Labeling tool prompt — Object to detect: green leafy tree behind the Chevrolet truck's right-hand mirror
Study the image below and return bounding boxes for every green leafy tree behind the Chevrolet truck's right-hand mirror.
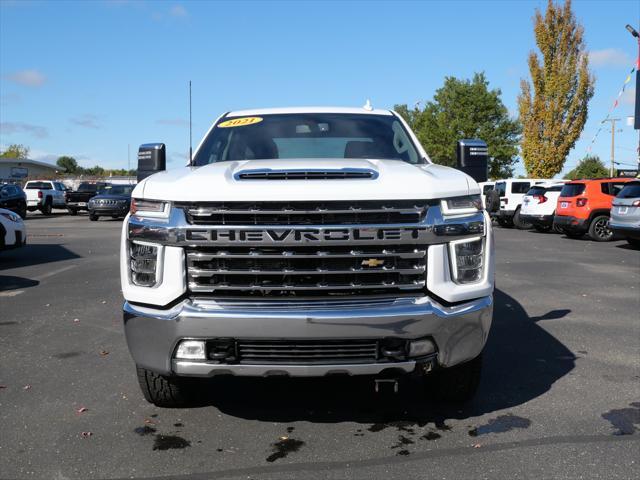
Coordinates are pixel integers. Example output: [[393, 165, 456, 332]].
[[395, 73, 521, 178]]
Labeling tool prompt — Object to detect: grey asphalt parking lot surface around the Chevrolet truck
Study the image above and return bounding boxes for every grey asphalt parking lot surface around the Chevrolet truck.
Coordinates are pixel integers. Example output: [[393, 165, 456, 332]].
[[0, 214, 640, 479]]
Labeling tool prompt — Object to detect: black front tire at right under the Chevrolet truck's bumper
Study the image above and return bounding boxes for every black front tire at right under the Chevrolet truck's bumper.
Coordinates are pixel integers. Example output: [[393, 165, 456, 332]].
[[425, 354, 482, 403]]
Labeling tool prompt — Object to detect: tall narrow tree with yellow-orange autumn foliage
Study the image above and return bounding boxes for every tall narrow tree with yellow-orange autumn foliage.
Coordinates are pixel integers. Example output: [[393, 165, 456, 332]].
[[518, 0, 595, 178]]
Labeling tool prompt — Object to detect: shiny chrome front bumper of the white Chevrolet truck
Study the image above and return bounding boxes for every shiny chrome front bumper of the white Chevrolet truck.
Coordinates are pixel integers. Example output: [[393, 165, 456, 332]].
[[124, 296, 493, 377]]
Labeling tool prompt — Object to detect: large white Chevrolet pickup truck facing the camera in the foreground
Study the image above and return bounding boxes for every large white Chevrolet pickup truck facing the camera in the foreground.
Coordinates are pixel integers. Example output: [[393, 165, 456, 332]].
[[121, 108, 494, 406]]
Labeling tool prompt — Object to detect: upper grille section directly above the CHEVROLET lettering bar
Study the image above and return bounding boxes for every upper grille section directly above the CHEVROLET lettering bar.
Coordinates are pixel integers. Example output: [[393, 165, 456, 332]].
[[177, 200, 429, 226]]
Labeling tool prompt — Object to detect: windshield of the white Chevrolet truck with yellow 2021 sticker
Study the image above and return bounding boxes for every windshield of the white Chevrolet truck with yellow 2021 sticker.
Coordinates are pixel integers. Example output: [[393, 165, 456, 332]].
[[194, 113, 422, 166]]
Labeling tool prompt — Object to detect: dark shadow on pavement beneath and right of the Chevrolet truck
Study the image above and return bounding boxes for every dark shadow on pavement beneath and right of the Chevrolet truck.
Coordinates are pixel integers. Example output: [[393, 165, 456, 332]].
[[199, 290, 576, 431]]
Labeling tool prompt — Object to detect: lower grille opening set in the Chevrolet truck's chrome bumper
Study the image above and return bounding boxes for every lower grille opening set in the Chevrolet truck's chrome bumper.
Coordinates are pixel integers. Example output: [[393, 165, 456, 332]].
[[236, 340, 378, 364]]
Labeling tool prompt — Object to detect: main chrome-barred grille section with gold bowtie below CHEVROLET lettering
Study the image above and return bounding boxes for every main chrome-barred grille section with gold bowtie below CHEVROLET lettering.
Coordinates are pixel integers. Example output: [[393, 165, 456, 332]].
[[187, 245, 427, 296]]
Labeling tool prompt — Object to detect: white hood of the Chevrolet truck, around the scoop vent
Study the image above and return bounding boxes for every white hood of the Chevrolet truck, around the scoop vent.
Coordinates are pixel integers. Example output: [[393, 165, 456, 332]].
[[133, 159, 478, 202]]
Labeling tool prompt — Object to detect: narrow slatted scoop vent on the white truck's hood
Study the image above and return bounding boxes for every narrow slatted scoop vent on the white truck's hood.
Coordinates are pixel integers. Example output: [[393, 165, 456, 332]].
[[233, 168, 378, 180]]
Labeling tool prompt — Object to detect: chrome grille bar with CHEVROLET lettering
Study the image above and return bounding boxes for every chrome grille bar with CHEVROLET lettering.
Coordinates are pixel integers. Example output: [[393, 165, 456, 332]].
[[186, 227, 427, 245]]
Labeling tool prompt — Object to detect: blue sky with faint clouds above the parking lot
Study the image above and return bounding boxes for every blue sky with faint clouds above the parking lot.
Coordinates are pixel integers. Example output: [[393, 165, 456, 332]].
[[0, 0, 640, 177]]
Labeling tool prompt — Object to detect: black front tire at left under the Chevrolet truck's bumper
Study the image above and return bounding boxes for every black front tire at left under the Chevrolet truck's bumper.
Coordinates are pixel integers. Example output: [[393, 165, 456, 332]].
[[136, 367, 194, 408]]
